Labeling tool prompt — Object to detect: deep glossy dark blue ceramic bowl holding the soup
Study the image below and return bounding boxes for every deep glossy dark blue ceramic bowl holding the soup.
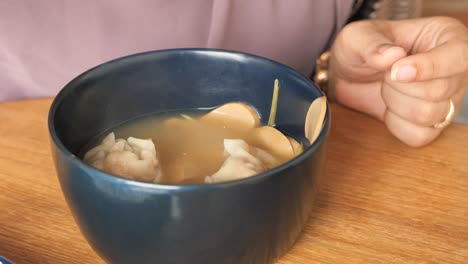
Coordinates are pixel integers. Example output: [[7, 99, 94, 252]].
[[49, 49, 330, 264]]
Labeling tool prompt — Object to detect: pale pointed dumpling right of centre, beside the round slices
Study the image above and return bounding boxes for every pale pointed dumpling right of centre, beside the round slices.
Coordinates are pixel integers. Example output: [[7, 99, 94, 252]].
[[205, 139, 277, 183]]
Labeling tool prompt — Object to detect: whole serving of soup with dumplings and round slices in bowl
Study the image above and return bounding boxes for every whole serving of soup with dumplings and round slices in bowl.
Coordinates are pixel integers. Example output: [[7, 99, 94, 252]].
[[83, 102, 302, 184]]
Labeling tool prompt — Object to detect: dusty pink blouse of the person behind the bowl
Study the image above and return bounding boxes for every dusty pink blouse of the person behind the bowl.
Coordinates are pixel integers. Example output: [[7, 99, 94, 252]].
[[0, 0, 353, 101]]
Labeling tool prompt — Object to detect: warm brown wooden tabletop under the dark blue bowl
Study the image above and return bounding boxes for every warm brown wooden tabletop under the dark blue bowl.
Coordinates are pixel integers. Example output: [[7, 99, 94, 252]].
[[0, 99, 468, 264]]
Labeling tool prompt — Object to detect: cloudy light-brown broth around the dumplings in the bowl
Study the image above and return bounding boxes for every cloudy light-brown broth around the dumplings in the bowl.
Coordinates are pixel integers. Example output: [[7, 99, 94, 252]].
[[82, 104, 302, 184]]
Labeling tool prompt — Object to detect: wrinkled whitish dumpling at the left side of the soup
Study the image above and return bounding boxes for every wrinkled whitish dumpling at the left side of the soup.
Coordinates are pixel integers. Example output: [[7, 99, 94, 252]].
[[83, 133, 161, 182]]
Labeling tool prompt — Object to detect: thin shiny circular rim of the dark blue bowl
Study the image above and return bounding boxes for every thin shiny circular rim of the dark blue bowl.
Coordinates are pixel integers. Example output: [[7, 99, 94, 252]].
[[47, 48, 331, 191]]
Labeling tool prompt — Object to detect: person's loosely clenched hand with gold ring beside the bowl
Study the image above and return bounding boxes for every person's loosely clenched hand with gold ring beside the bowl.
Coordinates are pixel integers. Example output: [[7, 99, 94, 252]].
[[329, 17, 468, 147]]
